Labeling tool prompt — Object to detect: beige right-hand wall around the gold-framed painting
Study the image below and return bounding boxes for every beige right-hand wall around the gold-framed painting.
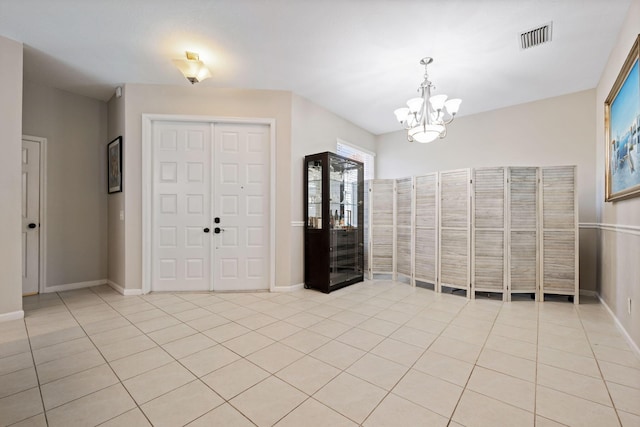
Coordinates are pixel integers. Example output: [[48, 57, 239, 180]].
[[595, 0, 640, 347]]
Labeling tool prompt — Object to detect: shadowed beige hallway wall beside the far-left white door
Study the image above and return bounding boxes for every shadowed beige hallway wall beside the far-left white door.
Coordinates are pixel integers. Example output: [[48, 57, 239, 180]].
[[22, 80, 107, 287]]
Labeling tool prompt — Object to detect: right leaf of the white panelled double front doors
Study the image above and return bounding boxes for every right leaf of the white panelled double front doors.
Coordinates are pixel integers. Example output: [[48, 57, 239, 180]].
[[213, 124, 270, 291]]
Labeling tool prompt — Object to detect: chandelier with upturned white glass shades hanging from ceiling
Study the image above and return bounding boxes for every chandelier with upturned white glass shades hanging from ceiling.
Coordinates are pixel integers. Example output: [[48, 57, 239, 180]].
[[394, 57, 462, 143]]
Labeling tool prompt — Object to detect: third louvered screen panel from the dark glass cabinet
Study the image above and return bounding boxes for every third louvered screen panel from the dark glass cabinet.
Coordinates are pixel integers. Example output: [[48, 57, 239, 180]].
[[414, 173, 438, 287]]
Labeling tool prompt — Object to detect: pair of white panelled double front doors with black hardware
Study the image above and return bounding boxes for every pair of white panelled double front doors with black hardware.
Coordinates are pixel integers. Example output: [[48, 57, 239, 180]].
[[151, 121, 271, 291]]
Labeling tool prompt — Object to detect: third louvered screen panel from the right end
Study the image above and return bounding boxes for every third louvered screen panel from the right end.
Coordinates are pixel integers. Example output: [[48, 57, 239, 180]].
[[471, 167, 507, 299]]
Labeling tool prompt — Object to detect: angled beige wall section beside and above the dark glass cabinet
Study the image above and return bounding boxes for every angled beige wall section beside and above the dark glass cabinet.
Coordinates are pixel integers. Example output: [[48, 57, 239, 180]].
[[290, 94, 376, 284]]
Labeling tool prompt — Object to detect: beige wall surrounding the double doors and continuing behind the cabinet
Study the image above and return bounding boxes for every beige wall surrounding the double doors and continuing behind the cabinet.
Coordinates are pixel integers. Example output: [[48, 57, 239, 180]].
[[109, 85, 375, 290]]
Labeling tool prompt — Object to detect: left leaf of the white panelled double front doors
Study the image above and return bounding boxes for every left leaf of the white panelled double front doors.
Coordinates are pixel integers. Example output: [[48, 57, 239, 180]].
[[151, 122, 212, 291]]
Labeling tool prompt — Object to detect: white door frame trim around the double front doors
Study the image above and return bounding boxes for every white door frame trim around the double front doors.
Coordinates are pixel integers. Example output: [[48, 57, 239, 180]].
[[141, 114, 276, 294]]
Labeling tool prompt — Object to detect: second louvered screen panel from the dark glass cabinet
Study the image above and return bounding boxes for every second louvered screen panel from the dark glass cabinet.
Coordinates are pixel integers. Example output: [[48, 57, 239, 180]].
[[395, 178, 413, 285]]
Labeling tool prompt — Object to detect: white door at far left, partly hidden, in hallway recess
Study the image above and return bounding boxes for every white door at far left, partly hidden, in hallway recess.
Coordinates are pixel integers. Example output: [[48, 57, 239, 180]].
[[22, 139, 40, 295]]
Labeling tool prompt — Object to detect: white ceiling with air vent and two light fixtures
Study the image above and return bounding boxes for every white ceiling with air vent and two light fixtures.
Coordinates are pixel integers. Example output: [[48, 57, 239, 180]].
[[0, 0, 630, 134]]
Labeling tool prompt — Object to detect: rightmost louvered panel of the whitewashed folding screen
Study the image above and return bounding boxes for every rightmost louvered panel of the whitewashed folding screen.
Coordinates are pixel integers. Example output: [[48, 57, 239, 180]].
[[540, 166, 579, 304]]
